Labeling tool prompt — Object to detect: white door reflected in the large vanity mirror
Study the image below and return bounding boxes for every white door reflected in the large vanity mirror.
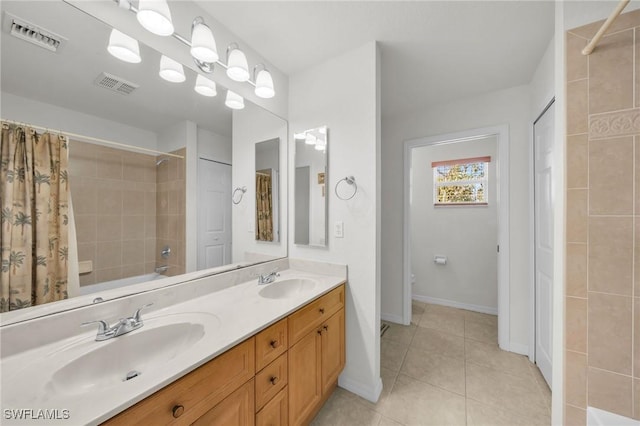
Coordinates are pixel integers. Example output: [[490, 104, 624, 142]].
[[198, 158, 231, 269]]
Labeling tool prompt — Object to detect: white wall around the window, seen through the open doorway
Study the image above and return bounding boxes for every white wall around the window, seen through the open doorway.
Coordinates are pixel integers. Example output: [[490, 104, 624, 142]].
[[410, 136, 498, 314]]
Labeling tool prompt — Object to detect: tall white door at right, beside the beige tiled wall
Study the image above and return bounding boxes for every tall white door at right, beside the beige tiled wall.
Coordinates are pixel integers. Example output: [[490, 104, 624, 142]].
[[533, 103, 555, 387]]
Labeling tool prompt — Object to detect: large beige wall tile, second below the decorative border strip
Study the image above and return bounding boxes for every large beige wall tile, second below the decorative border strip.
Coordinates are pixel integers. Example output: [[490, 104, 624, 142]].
[[589, 217, 633, 296]]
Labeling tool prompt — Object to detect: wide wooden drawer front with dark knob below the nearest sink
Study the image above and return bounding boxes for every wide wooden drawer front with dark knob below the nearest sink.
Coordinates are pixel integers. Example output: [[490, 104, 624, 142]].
[[104, 338, 255, 426]]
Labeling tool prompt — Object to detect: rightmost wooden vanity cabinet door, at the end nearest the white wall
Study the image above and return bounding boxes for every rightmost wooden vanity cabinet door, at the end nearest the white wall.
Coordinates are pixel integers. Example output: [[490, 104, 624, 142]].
[[321, 309, 345, 394]]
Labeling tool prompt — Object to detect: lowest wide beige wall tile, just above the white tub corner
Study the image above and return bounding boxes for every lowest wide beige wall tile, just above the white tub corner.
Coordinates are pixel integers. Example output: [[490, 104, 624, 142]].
[[588, 367, 633, 417]]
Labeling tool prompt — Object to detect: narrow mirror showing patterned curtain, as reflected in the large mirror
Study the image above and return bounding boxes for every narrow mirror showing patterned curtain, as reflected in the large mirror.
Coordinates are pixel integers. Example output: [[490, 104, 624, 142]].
[[256, 139, 280, 241]]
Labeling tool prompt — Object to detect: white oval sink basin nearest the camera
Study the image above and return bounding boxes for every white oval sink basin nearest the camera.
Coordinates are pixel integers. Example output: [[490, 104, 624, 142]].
[[46, 313, 220, 394]]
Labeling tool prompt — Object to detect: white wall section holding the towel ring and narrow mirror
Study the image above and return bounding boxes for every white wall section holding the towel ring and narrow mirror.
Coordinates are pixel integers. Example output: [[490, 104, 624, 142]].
[[289, 42, 382, 400]]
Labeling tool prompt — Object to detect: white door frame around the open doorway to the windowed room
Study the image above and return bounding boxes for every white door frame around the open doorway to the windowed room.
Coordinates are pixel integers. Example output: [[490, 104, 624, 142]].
[[402, 124, 511, 351]]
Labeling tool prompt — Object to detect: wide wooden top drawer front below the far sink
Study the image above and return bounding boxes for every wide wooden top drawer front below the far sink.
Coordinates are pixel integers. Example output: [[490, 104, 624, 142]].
[[289, 284, 344, 347]]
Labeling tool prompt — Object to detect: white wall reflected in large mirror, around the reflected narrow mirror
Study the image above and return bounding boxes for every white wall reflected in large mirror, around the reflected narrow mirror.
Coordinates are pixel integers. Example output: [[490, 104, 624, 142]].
[[231, 102, 289, 262]]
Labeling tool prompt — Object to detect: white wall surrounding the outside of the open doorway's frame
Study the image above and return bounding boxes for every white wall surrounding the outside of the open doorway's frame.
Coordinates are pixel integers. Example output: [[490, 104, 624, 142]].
[[382, 86, 531, 352]]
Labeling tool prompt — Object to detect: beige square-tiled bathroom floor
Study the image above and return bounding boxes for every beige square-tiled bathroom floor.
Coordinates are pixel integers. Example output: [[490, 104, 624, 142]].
[[312, 302, 551, 426]]
